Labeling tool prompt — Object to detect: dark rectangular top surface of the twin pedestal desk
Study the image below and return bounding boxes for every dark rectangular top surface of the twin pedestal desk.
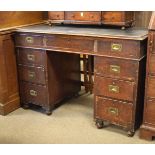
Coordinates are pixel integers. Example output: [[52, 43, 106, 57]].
[[15, 24, 148, 40]]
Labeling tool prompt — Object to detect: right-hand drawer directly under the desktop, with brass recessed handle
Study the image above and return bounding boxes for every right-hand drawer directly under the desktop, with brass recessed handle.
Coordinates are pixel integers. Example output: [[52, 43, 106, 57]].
[[97, 39, 141, 58]]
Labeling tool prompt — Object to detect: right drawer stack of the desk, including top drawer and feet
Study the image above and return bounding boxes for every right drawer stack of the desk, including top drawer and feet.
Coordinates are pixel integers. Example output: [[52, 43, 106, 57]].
[[94, 39, 147, 136]]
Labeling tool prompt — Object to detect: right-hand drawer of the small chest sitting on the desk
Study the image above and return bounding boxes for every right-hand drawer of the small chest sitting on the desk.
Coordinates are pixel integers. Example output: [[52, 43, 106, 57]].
[[102, 11, 124, 23]]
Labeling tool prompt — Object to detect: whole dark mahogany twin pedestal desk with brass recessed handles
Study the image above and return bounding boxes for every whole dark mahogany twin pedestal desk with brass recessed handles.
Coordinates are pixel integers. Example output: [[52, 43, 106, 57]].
[[15, 25, 148, 136]]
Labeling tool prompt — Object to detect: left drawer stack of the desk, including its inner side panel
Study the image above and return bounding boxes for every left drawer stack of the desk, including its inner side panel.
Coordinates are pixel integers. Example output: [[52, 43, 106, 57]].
[[15, 33, 80, 114]]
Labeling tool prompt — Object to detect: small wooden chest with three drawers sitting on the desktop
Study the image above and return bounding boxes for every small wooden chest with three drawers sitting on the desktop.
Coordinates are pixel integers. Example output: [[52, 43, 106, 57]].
[[48, 11, 134, 27]]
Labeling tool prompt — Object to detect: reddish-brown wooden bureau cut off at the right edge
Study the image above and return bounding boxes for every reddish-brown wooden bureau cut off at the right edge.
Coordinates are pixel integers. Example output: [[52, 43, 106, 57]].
[[140, 12, 155, 140]]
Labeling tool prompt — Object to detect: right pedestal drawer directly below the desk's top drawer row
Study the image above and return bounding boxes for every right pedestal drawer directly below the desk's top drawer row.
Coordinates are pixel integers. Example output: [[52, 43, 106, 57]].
[[95, 56, 139, 80]]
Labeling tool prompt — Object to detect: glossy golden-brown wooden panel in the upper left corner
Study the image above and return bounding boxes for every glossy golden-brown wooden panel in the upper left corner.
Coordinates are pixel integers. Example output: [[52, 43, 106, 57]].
[[0, 11, 46, 29]]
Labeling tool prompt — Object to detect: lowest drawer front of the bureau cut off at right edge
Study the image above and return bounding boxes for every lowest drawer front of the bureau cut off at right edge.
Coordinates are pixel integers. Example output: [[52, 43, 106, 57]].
[[144, 100, 155, 125]]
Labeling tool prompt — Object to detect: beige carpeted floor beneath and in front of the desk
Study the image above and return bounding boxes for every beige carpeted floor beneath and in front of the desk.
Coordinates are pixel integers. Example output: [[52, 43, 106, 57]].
[[0, 94, 155, 144]]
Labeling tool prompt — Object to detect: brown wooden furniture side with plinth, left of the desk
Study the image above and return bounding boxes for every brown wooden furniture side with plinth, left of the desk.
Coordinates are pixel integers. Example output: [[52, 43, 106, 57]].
[[0, 33, 20, 115]]
